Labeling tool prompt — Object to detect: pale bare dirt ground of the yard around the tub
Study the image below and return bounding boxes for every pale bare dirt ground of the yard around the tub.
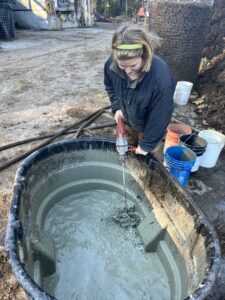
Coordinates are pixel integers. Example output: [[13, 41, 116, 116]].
[[0, 15, 225, 300]]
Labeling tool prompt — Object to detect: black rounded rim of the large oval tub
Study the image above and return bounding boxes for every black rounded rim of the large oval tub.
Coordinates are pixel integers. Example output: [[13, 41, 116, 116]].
[[5, 137, 221, 300]]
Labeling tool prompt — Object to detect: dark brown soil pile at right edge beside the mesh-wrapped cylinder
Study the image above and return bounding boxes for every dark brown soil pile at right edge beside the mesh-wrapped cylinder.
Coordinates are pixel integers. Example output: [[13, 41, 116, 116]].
[[196, 0, 225, 134]]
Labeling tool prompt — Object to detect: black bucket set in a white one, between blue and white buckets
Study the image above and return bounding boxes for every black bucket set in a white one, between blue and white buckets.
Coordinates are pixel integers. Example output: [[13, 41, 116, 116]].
[[179, 134, 207, 172]]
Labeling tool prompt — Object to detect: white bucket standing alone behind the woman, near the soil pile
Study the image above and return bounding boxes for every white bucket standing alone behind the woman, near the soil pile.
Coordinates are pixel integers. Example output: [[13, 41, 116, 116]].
[[173, 81, 193, 105]]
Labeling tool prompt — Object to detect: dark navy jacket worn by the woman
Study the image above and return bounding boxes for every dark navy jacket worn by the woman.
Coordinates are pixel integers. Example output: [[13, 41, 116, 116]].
[[104, 56, 176, 152]]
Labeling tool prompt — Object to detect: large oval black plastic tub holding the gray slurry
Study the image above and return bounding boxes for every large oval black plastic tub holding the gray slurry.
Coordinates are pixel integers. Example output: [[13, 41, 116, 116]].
[[6, 137, 220, 300]]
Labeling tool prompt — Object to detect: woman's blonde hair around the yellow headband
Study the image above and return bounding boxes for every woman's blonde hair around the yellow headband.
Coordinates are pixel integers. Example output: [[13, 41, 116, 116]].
[[112, 25, 161, 72]]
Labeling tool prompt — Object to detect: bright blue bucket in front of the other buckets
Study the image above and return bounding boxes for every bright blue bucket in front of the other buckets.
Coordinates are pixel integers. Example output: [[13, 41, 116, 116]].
[[165, 146, 196, 187]]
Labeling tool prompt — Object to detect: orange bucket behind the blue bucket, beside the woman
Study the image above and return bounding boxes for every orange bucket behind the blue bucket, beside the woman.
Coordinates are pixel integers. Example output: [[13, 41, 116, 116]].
[[164, 124, 192, 153]]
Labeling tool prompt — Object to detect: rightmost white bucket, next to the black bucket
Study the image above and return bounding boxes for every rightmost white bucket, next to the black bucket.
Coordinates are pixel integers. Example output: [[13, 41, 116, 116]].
[[199, 130, 225, 168]]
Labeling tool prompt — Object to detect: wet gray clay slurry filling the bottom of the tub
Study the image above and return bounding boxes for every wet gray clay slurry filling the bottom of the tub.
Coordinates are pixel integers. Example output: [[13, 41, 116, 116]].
[[44, 190, 170, 300]]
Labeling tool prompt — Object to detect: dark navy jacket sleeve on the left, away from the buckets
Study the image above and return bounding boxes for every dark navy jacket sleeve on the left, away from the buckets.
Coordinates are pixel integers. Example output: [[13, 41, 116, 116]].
[[104, 60, 120, 113]]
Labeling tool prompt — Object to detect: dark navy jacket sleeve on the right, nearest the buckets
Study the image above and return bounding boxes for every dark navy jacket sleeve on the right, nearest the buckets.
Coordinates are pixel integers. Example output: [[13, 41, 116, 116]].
[[139, 86, 175, 152]]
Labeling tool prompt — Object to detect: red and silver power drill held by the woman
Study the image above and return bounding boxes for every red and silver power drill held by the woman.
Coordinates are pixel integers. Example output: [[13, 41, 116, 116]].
[[116, 116, 137, 161]]
